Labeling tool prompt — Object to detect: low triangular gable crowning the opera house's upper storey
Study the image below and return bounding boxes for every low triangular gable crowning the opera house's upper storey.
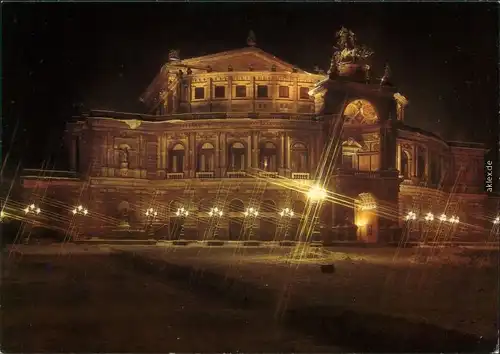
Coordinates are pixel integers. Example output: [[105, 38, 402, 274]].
[[170, 47, 304, 73]]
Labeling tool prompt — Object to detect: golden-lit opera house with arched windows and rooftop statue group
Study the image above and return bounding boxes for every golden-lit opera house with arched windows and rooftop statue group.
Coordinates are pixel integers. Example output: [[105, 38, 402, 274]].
[[22, 29, 494, 243]]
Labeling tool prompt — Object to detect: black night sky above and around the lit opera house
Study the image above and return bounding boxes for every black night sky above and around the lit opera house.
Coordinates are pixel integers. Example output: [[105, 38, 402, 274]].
[[2, 3, 499, 167]]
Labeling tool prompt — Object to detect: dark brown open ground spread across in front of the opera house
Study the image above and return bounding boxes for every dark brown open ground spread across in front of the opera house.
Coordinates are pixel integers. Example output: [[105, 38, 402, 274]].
[[1, 244, 498, 353]]
